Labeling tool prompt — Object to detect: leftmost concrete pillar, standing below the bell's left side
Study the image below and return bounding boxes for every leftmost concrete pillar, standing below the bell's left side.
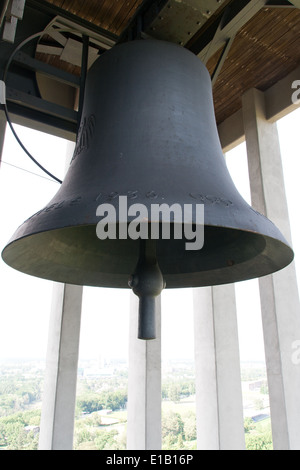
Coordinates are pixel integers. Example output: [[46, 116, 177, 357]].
[[39, 283, 82, 450]]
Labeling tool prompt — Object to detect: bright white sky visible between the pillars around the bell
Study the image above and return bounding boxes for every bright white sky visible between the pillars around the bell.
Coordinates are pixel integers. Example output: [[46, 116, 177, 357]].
[[0, 104, 300, 361]]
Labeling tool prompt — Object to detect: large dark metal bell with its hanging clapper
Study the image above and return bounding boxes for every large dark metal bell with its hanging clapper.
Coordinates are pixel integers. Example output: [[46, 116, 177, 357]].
[[2, 39, 293, 338]]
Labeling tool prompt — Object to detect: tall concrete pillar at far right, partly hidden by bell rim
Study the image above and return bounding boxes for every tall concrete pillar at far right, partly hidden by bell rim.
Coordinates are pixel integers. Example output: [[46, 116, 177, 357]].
[[243, 89, 300, 450]]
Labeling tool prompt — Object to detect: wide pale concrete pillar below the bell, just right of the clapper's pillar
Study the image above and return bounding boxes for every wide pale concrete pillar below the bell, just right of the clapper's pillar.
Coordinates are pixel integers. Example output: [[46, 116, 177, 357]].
[[194, 284, 245, 450]]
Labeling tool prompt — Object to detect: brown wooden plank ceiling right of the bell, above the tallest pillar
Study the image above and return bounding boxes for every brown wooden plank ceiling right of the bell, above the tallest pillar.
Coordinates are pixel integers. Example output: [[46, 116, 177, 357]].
[[207, 8, 300, 124]]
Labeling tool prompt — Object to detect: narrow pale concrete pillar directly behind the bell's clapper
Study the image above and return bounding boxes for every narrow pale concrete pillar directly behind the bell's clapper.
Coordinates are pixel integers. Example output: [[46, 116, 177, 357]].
[[127, 293, 161, 450]]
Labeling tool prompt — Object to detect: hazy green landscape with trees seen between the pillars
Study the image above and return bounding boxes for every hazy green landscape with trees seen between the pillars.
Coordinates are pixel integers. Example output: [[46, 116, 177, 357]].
[[0, 355, 272, 450]]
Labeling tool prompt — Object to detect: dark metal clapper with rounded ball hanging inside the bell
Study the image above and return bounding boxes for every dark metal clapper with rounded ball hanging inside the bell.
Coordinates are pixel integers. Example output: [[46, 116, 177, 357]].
[[128, 240, 165, 340]]
